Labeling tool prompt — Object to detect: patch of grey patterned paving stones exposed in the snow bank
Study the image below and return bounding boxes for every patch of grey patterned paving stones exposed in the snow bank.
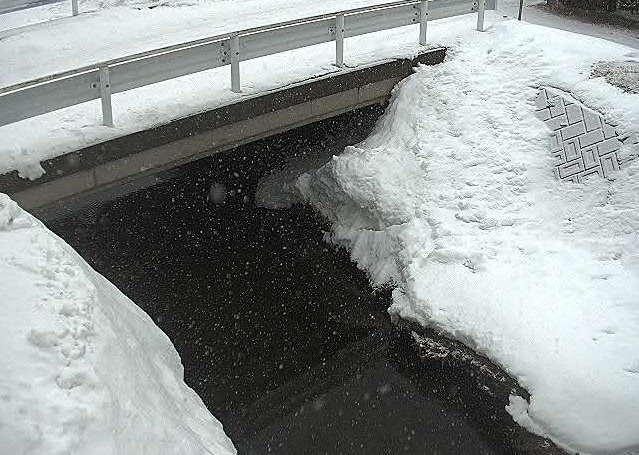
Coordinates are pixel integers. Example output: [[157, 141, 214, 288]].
[[535, 88, 634, 183]]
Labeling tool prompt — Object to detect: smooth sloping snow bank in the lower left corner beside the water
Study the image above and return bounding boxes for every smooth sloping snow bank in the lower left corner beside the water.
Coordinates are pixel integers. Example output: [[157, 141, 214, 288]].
[[0, 194, 236, 455]]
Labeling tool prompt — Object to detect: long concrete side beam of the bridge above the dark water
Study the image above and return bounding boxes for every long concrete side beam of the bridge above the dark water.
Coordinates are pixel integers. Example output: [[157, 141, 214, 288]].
[[0, 49, 445, 209]]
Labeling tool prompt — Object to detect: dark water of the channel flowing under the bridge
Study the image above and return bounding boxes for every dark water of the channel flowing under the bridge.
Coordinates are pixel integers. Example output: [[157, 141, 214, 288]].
[[45, 108, 504, 455]]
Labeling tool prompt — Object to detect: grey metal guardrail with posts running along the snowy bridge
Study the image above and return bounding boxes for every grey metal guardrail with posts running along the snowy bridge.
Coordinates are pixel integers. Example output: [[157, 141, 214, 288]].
[[0, 0, 494, 126]]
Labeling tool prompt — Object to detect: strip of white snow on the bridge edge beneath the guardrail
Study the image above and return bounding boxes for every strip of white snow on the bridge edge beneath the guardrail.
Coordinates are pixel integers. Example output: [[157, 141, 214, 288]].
[[0, 8, 470, 179]]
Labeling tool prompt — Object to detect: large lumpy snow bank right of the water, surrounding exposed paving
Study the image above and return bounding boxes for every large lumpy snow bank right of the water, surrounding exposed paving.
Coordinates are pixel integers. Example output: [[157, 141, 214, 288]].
[[296, 21, 639, 454]]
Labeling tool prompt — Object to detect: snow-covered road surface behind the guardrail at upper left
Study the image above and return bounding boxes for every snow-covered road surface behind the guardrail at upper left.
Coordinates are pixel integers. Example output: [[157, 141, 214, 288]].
[[0, 0, 388, 87]]
